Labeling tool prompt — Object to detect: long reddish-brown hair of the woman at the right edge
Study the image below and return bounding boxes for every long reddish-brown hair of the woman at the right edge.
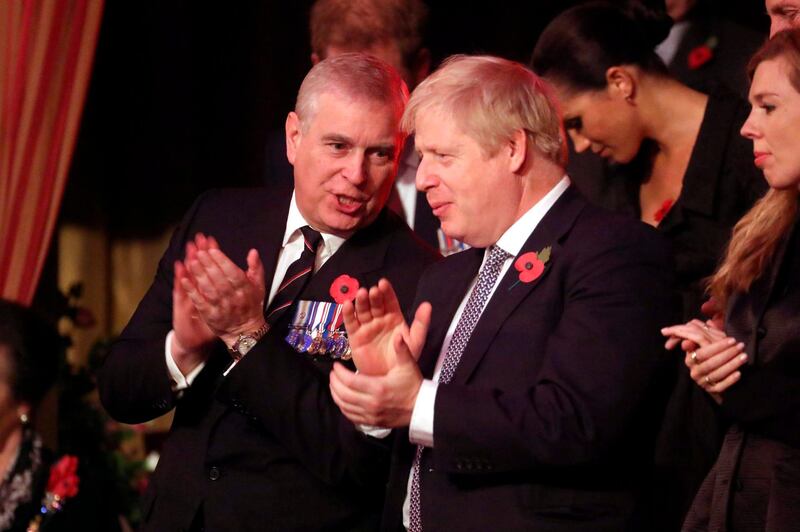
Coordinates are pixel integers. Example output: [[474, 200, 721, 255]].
[[708, 29, 800, 308]]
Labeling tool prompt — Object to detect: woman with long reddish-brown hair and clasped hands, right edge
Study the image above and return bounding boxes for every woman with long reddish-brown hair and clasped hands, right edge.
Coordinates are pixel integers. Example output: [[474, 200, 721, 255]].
[[663, 29, 800, 531]]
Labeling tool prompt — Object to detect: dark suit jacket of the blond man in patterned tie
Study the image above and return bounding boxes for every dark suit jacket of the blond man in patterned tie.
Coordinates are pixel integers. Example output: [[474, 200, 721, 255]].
[[383, 187, 677, 531]]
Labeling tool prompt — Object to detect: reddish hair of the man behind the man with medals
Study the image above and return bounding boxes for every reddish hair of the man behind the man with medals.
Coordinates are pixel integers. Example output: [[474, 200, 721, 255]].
[[310, 0, 428, 68]]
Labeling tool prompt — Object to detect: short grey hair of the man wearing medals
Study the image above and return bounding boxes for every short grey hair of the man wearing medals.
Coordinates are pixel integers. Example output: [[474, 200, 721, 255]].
[[295, 53, 408, 130]]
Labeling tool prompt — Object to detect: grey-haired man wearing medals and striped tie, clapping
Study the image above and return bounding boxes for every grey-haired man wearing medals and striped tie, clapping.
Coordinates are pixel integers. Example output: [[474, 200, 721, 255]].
[[99, 54, 435, 531]]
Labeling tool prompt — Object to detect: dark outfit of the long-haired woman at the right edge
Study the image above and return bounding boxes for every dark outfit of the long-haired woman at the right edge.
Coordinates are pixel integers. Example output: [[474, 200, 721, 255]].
[[684, 203, 800, 532]]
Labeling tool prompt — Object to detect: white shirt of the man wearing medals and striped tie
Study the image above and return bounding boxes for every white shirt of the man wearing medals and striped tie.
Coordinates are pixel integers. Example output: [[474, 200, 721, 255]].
[[164, 192, 346, 391]]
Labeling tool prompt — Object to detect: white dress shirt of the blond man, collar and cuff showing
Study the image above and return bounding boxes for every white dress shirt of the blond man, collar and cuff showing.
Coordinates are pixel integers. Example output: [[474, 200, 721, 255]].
[[403, 175, 570, 528]]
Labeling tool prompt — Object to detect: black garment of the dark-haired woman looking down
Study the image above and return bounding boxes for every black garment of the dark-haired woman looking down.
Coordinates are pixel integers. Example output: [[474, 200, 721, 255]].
[[580, 88, 767, 531]]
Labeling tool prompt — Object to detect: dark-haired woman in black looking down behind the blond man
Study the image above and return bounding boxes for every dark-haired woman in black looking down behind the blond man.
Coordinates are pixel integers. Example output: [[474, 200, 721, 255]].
[[532, 2, 766, 530]]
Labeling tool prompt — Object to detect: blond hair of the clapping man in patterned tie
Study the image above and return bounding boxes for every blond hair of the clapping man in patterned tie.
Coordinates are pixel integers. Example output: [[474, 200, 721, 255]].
[[400, 55, 566, 166]]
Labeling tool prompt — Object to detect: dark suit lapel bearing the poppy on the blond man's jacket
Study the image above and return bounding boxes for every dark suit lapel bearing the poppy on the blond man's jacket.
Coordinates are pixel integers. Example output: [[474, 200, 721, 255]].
[[451, 187, 586, 384]]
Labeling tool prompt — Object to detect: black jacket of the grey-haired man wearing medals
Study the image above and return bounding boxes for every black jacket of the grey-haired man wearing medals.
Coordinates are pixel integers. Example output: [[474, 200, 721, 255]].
[[99, 181, 435, 532]]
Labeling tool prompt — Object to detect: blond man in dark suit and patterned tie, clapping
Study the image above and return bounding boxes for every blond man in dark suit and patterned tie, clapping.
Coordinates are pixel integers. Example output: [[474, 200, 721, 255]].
[[331, 56, 677, 532]]
